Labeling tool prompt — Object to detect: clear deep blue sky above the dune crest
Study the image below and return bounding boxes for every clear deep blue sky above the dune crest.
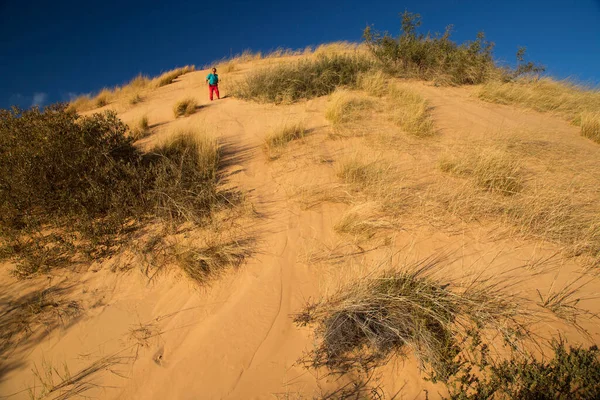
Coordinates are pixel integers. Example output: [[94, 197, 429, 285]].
[[0, 0, 600, 108]]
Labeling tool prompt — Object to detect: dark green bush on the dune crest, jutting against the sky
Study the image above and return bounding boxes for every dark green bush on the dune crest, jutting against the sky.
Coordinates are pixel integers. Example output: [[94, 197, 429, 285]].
[[363, 11, 500, 85]]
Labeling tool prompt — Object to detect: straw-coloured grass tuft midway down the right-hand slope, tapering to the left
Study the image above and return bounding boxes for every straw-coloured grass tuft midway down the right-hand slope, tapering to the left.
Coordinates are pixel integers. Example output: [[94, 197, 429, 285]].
[[439, 149, 523, 195]]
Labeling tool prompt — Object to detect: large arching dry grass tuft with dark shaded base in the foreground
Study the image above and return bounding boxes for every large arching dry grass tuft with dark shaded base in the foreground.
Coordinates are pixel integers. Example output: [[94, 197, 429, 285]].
[[295, 258, 538, 377]]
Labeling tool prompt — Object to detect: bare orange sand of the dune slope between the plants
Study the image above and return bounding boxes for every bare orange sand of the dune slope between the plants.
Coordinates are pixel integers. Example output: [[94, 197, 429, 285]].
[[0, 57, 600, 399]]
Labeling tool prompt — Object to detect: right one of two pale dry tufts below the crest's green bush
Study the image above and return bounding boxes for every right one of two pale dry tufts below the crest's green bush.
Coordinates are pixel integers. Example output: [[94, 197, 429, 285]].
[[388, 85, 435, 137]]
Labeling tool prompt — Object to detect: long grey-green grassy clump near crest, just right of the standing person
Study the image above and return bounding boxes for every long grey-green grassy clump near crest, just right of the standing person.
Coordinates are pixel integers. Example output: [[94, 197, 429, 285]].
[[234, 54, 372, 103]]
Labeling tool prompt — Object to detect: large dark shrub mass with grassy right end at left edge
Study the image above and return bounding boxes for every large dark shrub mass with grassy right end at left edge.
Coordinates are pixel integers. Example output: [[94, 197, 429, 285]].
[[0, 105, 225, 276]]
